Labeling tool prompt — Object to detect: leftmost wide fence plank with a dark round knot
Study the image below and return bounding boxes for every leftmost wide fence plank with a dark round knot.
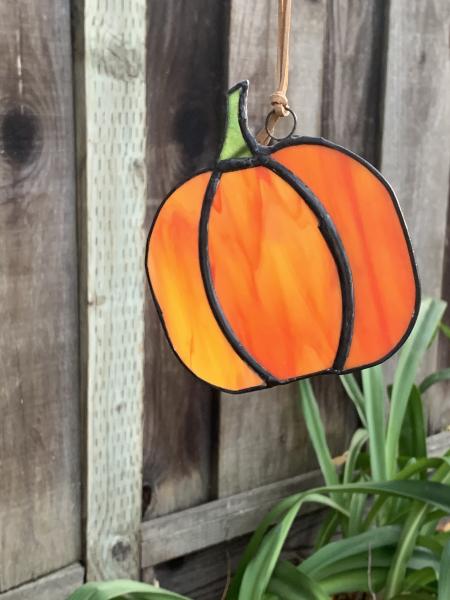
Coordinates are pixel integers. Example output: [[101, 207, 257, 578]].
[[0, 0, 81, 591]]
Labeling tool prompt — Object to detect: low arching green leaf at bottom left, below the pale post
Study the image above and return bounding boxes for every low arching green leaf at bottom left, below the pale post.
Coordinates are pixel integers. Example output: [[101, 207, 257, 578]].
[[67, 579, 189, 600]]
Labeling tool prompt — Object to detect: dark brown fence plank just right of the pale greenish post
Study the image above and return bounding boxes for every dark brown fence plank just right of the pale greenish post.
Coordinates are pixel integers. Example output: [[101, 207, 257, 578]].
[[144, 0, 228, 519]]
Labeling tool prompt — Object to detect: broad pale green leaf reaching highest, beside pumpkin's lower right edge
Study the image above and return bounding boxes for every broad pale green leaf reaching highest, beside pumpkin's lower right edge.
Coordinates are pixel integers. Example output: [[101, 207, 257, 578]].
[[386, 298, 446, 478]]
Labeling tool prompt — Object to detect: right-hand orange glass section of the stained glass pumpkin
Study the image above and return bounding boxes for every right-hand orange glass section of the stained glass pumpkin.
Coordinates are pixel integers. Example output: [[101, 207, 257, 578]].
[[272, 144, 416, 369]]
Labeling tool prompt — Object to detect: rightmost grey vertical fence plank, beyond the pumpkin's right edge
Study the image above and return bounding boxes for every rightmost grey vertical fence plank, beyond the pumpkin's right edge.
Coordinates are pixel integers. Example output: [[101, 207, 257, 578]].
[[382, 0, 450, 431]]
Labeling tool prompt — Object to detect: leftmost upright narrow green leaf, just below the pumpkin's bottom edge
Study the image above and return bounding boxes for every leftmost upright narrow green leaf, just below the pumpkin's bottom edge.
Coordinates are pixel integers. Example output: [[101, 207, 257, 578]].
[[299, 379, 339, 485]]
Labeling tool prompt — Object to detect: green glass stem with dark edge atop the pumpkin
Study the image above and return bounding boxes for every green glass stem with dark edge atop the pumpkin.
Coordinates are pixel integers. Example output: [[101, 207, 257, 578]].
[[219, 81, 252, 161]]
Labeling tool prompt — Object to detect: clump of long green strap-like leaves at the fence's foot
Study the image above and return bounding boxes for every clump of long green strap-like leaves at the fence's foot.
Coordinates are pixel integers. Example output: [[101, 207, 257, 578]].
[[69, 299, 450, 600]]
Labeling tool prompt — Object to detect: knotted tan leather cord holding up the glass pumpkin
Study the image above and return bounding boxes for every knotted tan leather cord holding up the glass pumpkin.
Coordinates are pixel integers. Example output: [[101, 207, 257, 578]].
[[256, 0, 292, 145]]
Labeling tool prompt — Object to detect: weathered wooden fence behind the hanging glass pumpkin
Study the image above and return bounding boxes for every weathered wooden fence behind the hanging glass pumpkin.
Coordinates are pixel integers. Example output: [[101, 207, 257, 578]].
[[0, 0, 450, 600]]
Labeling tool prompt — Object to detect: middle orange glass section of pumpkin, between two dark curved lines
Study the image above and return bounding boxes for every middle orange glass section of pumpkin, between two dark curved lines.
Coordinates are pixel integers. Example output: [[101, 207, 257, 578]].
[[208, 167, 342, 380]]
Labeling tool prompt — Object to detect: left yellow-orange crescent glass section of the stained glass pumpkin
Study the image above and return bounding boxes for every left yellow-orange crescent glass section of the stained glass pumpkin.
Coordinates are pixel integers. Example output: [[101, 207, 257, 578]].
[[147, 173, 264, 391]]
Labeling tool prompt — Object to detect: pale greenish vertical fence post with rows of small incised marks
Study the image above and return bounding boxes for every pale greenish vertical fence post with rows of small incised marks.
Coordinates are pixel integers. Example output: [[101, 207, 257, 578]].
[[75, 0, 146, 580]]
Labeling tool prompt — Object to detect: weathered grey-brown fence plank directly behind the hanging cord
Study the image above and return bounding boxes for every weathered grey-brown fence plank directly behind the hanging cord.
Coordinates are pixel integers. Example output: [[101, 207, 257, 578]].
[[218, 0, 384, 496]]
